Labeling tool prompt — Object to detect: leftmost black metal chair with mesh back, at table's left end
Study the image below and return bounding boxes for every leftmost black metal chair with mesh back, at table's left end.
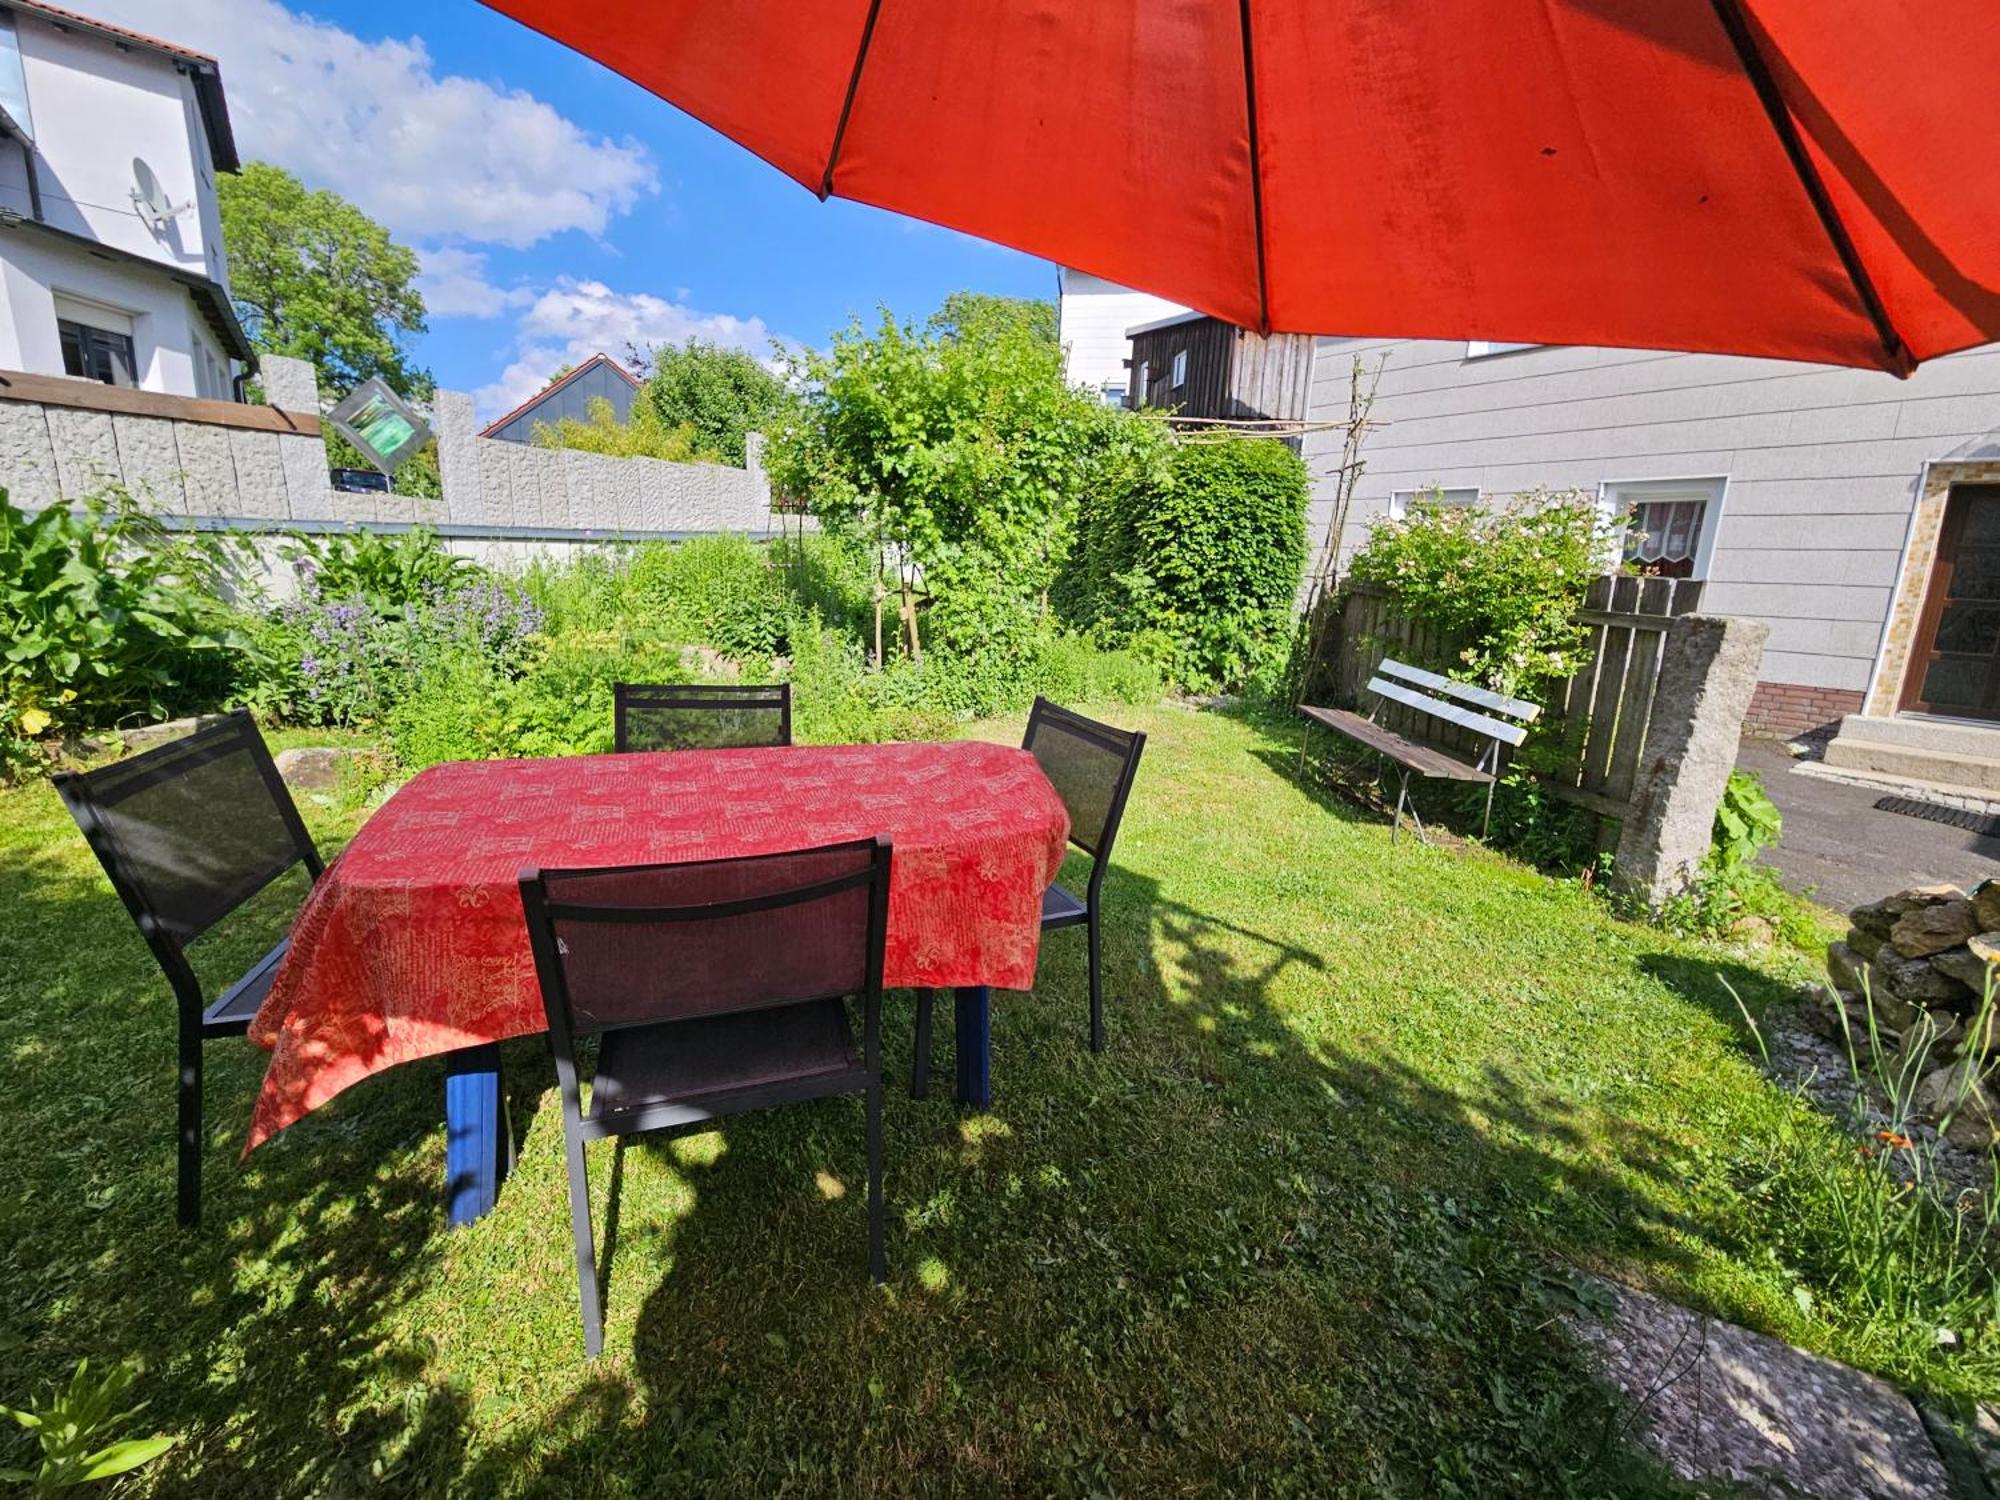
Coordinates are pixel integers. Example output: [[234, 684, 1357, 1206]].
[[54, 710, 324, 1224]]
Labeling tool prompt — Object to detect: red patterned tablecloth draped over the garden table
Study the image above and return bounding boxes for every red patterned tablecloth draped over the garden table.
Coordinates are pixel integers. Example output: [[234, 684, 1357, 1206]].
[[250, 740, 1070, 1146]]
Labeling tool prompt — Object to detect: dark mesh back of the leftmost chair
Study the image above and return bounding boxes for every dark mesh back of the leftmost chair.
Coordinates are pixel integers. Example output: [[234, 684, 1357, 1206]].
[[54, 712, 320, 944]]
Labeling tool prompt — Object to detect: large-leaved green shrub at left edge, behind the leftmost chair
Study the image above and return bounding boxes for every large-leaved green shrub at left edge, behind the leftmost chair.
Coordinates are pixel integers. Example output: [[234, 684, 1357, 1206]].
[[0, 488, 244, 768]]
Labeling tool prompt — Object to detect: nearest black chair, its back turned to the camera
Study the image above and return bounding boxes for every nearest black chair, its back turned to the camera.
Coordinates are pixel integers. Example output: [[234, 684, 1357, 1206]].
[[520, 836, 890, 1358]]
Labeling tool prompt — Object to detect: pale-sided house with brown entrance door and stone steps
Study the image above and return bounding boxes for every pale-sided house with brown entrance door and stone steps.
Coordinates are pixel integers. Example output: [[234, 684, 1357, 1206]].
[[1304, 338, 2000, 790]]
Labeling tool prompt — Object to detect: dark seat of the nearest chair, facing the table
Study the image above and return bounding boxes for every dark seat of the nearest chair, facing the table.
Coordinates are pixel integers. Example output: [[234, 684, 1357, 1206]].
[[584, 1000, 868, 1136]]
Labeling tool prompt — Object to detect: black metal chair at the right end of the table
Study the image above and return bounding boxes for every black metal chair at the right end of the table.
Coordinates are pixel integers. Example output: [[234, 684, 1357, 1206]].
[[910, 696, 1146, 1098]]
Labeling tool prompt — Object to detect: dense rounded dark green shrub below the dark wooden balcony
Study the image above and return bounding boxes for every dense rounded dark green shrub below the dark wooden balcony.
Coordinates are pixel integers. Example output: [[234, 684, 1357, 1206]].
[[1060, 438, 1306, 688]]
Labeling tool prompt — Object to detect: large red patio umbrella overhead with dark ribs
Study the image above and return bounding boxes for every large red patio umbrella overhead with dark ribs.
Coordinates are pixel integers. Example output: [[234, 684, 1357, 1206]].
[[488, 0, 2000, 374]]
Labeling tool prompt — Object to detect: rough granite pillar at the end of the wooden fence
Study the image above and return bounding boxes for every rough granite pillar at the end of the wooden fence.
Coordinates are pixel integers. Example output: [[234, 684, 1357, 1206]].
[[1614, 614, 1770, 908]]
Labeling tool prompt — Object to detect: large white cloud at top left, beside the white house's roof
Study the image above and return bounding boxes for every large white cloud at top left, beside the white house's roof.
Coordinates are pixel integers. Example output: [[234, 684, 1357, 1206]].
[[84, 0, 660, 250]]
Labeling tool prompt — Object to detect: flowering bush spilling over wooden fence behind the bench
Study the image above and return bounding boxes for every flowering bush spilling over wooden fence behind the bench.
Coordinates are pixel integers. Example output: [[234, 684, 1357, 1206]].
[[1348, 490, 1614, 696]]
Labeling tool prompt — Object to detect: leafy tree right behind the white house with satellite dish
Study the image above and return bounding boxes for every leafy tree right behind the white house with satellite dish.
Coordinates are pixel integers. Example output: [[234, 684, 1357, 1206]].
[[220, 162, 434, 400]]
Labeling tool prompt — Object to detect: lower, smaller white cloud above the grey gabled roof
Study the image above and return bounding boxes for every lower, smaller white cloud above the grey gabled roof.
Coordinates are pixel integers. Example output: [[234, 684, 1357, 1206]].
[[472, 276, 792, 422]]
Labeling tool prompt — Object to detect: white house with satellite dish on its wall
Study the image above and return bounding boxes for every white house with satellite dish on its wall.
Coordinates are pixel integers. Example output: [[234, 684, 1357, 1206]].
[[0, 0, 254, 400]]
